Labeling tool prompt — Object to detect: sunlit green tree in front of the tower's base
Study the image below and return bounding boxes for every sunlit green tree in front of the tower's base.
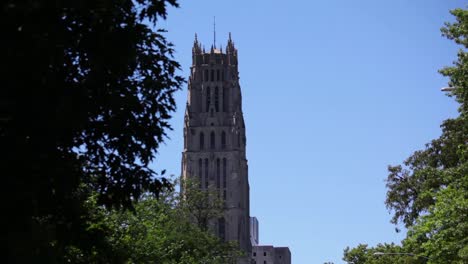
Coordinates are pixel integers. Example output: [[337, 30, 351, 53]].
[[83, 182, 240, 264]]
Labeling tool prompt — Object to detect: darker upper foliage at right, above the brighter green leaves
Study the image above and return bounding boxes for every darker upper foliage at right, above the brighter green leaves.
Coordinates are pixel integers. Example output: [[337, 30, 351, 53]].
[[385, 9, 468, 227]]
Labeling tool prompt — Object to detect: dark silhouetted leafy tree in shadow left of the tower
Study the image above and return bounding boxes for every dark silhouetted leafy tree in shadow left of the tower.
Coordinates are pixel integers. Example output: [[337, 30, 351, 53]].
[[0, 0, 183, 263]]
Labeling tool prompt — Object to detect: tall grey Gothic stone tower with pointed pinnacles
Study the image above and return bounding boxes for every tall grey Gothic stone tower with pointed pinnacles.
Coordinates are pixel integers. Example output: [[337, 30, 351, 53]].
[[182, 34, 252, 263]]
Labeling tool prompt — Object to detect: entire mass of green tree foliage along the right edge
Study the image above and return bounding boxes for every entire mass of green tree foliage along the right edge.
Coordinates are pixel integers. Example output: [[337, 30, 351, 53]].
[[344, 9, 468, 263]]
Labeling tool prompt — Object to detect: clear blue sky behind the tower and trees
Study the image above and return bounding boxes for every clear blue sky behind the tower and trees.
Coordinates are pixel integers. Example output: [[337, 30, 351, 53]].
[[154, 0, 466, 264]]
